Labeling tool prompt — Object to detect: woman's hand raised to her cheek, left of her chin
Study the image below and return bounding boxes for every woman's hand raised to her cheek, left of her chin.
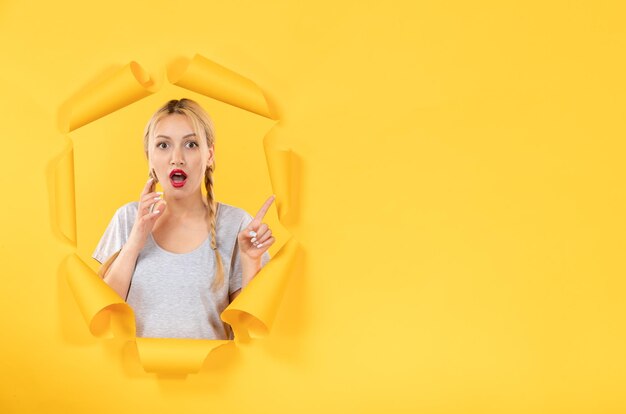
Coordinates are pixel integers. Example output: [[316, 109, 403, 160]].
[[128, 178, 167, 250]]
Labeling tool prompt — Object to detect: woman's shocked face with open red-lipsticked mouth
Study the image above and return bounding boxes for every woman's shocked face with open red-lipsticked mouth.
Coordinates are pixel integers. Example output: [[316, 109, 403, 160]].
[[148, 114, 213, 198]]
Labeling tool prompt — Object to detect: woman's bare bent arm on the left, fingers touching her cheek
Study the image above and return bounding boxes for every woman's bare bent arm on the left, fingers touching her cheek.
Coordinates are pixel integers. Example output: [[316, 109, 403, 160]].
[[102, 178, 166, 300]]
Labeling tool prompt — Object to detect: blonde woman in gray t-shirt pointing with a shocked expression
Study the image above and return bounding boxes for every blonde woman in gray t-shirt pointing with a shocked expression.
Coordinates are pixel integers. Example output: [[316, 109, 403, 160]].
[[93, 99, 275, 339]]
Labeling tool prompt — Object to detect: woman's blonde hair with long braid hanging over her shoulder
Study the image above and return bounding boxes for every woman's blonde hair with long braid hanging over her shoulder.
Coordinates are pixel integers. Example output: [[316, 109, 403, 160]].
[[143, 98, 224, 290]]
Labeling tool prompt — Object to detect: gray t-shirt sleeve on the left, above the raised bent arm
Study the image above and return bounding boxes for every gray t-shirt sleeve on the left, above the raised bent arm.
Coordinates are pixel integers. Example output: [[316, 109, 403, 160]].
[[91, 203, 137, 264]]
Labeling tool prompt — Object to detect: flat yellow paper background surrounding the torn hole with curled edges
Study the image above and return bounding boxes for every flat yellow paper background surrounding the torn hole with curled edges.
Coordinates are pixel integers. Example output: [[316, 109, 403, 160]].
[[0, 1, 626, 413]]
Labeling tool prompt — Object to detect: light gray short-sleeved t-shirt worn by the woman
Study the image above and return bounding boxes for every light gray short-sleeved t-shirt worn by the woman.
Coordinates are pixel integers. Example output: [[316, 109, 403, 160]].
[[92, 202, 270, 339]]
